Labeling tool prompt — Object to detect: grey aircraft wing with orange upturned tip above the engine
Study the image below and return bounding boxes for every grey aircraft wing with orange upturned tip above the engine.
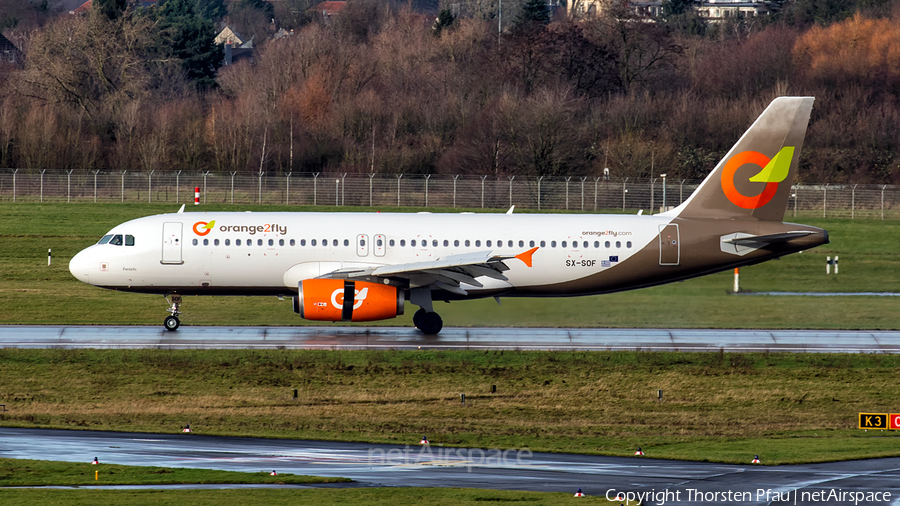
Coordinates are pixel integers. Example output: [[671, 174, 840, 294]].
[[324, 248, 538, 295]]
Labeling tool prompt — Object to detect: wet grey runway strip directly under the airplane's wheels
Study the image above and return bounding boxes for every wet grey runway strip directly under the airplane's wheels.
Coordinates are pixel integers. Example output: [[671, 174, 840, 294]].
[[0, 325, 900, 353]]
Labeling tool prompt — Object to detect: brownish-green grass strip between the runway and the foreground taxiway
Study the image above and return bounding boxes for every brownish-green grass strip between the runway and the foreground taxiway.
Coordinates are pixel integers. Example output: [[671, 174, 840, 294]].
[[0, 349, 900, 464]]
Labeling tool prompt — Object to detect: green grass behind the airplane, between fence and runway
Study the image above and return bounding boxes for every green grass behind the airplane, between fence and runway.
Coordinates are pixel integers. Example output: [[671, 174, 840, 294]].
[[0, 203, 900, 329]]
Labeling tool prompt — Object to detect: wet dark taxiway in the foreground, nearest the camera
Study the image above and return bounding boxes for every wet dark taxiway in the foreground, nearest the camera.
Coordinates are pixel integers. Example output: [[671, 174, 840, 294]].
[[0, 428, 900, 505]]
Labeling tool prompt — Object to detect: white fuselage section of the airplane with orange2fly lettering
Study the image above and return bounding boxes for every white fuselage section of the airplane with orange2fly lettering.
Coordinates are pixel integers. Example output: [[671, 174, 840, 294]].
[[70, 212, 673, 297]]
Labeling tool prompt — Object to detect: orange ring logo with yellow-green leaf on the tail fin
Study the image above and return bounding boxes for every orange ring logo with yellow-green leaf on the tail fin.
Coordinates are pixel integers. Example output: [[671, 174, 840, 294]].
[[722, 146, 794, 209]]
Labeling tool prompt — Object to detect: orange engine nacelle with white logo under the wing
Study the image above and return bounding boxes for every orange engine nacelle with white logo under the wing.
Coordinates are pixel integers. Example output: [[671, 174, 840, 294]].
[[294, 279, 404, 322]]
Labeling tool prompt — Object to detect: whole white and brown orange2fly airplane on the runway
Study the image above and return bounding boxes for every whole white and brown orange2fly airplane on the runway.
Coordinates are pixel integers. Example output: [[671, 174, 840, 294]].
[[69, 97, 828, 335]]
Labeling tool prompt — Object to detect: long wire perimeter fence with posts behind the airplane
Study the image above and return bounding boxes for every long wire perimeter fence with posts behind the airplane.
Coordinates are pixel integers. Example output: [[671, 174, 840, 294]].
[[0, 169, 900, 220]]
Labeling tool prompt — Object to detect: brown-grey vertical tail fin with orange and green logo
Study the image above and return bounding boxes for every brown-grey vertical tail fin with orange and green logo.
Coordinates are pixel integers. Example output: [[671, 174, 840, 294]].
[[671, 97, 815, 221]]
